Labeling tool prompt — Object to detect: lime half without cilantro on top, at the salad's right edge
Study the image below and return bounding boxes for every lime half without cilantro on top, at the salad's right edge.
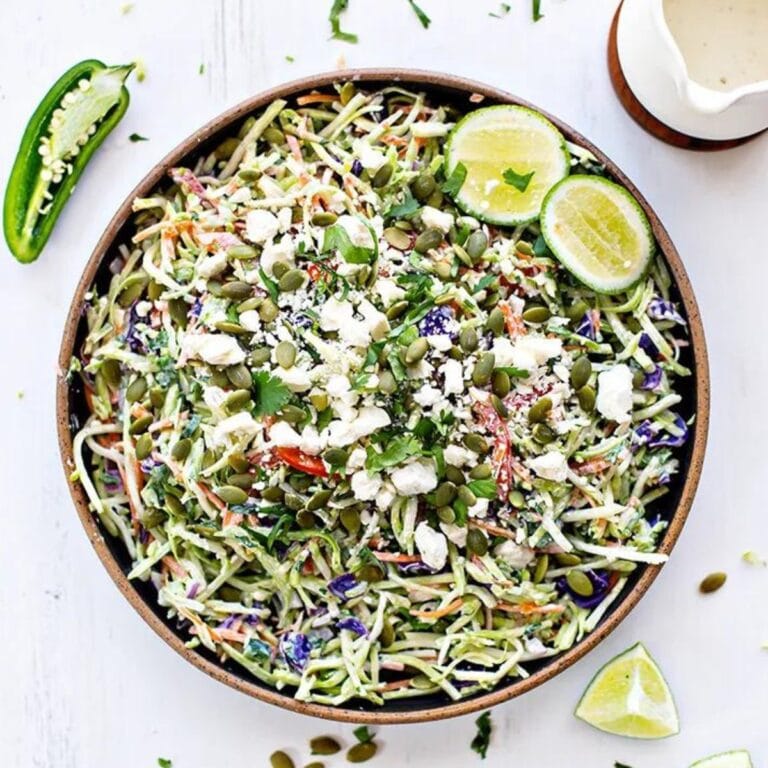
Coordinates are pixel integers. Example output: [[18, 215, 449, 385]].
[[541, 175, 655, 293]]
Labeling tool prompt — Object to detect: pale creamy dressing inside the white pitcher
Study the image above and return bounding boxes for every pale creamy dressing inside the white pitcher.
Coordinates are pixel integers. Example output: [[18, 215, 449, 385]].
[[664, 0, 768, 91]]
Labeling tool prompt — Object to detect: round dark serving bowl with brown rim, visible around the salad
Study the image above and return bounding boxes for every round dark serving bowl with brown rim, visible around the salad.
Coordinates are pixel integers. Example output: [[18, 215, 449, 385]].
[[56, 69, 709, 724]]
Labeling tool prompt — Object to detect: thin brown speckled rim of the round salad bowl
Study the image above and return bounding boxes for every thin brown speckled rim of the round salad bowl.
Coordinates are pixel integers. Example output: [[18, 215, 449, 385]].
[[56, 68, 710, 725]]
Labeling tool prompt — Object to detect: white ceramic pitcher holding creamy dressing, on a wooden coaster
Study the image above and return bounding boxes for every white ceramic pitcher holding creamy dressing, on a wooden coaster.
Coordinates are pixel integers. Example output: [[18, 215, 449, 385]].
[[616, 0, 768, 140]]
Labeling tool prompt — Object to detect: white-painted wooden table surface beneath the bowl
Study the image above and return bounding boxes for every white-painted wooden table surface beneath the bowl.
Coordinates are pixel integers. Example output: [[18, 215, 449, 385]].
[[0, 0, 768, 768]]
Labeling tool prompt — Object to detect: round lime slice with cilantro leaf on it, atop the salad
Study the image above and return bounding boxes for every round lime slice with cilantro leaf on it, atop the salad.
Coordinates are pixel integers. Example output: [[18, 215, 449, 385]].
[[445, 105, 571, 225]]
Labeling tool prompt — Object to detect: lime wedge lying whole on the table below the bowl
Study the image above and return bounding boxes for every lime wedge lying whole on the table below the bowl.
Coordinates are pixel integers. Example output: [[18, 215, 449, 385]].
[[575, 643, 680, 739]]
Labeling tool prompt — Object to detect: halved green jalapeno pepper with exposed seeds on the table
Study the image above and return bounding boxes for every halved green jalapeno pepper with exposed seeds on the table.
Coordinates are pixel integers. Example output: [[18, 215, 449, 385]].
[[3, 59, 134, 263]]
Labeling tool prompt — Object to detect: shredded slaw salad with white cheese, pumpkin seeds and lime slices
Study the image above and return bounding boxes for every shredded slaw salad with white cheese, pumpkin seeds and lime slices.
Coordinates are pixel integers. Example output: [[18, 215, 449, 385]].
[[67, 83, 693, 705]]
